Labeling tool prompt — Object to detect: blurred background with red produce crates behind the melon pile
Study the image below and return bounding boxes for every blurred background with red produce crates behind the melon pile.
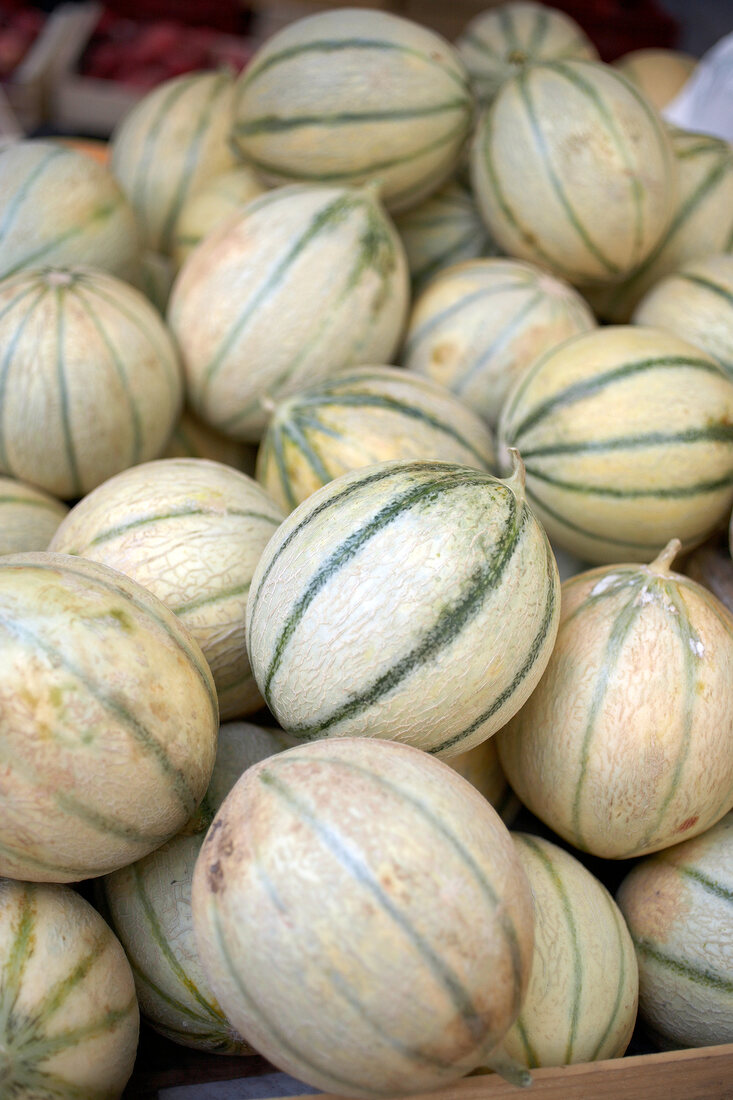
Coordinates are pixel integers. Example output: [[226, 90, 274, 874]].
[[0, 0, 733, 138]]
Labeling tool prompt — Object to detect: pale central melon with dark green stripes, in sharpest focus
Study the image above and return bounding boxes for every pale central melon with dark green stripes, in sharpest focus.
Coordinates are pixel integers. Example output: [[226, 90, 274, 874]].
[[247, 461, 559, 757]]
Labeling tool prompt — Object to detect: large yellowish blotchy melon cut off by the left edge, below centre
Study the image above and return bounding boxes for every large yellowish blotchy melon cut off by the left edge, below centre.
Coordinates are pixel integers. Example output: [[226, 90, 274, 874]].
[[0, 552, 219, 882]]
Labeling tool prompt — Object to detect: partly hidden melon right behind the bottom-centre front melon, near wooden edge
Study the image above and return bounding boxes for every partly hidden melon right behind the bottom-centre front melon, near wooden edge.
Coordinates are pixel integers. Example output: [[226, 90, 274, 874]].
[[502, 833, 638, 1068]]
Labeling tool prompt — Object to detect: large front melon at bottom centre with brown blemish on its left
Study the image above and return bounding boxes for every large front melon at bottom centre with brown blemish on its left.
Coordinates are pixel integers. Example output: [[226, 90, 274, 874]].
[[193, 738, 533, 1098]]
